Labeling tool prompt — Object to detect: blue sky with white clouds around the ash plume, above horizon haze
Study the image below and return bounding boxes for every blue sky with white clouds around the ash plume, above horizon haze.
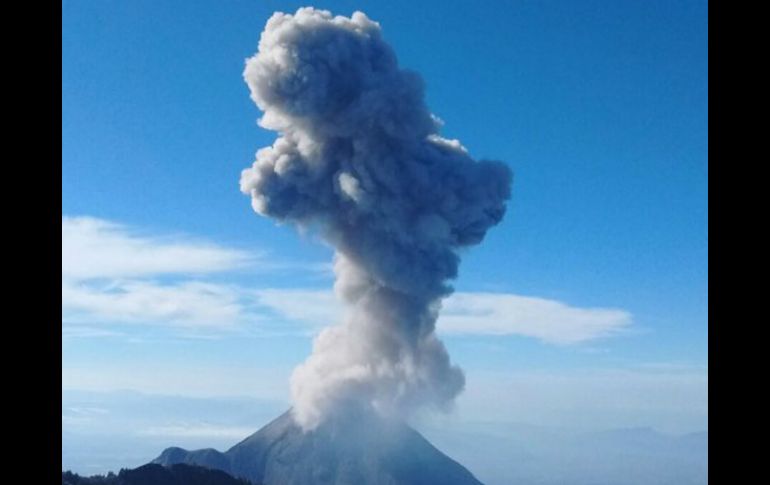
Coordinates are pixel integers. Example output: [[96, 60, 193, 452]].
[[62, 0, 708, 468]]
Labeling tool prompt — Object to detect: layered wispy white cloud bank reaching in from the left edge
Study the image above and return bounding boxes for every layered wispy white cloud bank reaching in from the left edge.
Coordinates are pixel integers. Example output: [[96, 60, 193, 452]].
[[62, 216, 304, 330]]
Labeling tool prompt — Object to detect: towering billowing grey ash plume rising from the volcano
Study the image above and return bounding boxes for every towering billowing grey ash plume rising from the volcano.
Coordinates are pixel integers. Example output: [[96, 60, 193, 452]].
[[241, 8, 512, 430]]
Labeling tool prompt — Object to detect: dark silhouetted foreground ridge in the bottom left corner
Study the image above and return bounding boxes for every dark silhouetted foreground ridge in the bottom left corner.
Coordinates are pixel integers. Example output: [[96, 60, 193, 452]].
[[61, 463, 256, 485]]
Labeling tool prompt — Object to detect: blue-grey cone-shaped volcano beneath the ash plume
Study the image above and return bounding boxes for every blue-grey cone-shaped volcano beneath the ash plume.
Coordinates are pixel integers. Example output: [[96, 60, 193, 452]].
[[153, 410, 482, 485]]
